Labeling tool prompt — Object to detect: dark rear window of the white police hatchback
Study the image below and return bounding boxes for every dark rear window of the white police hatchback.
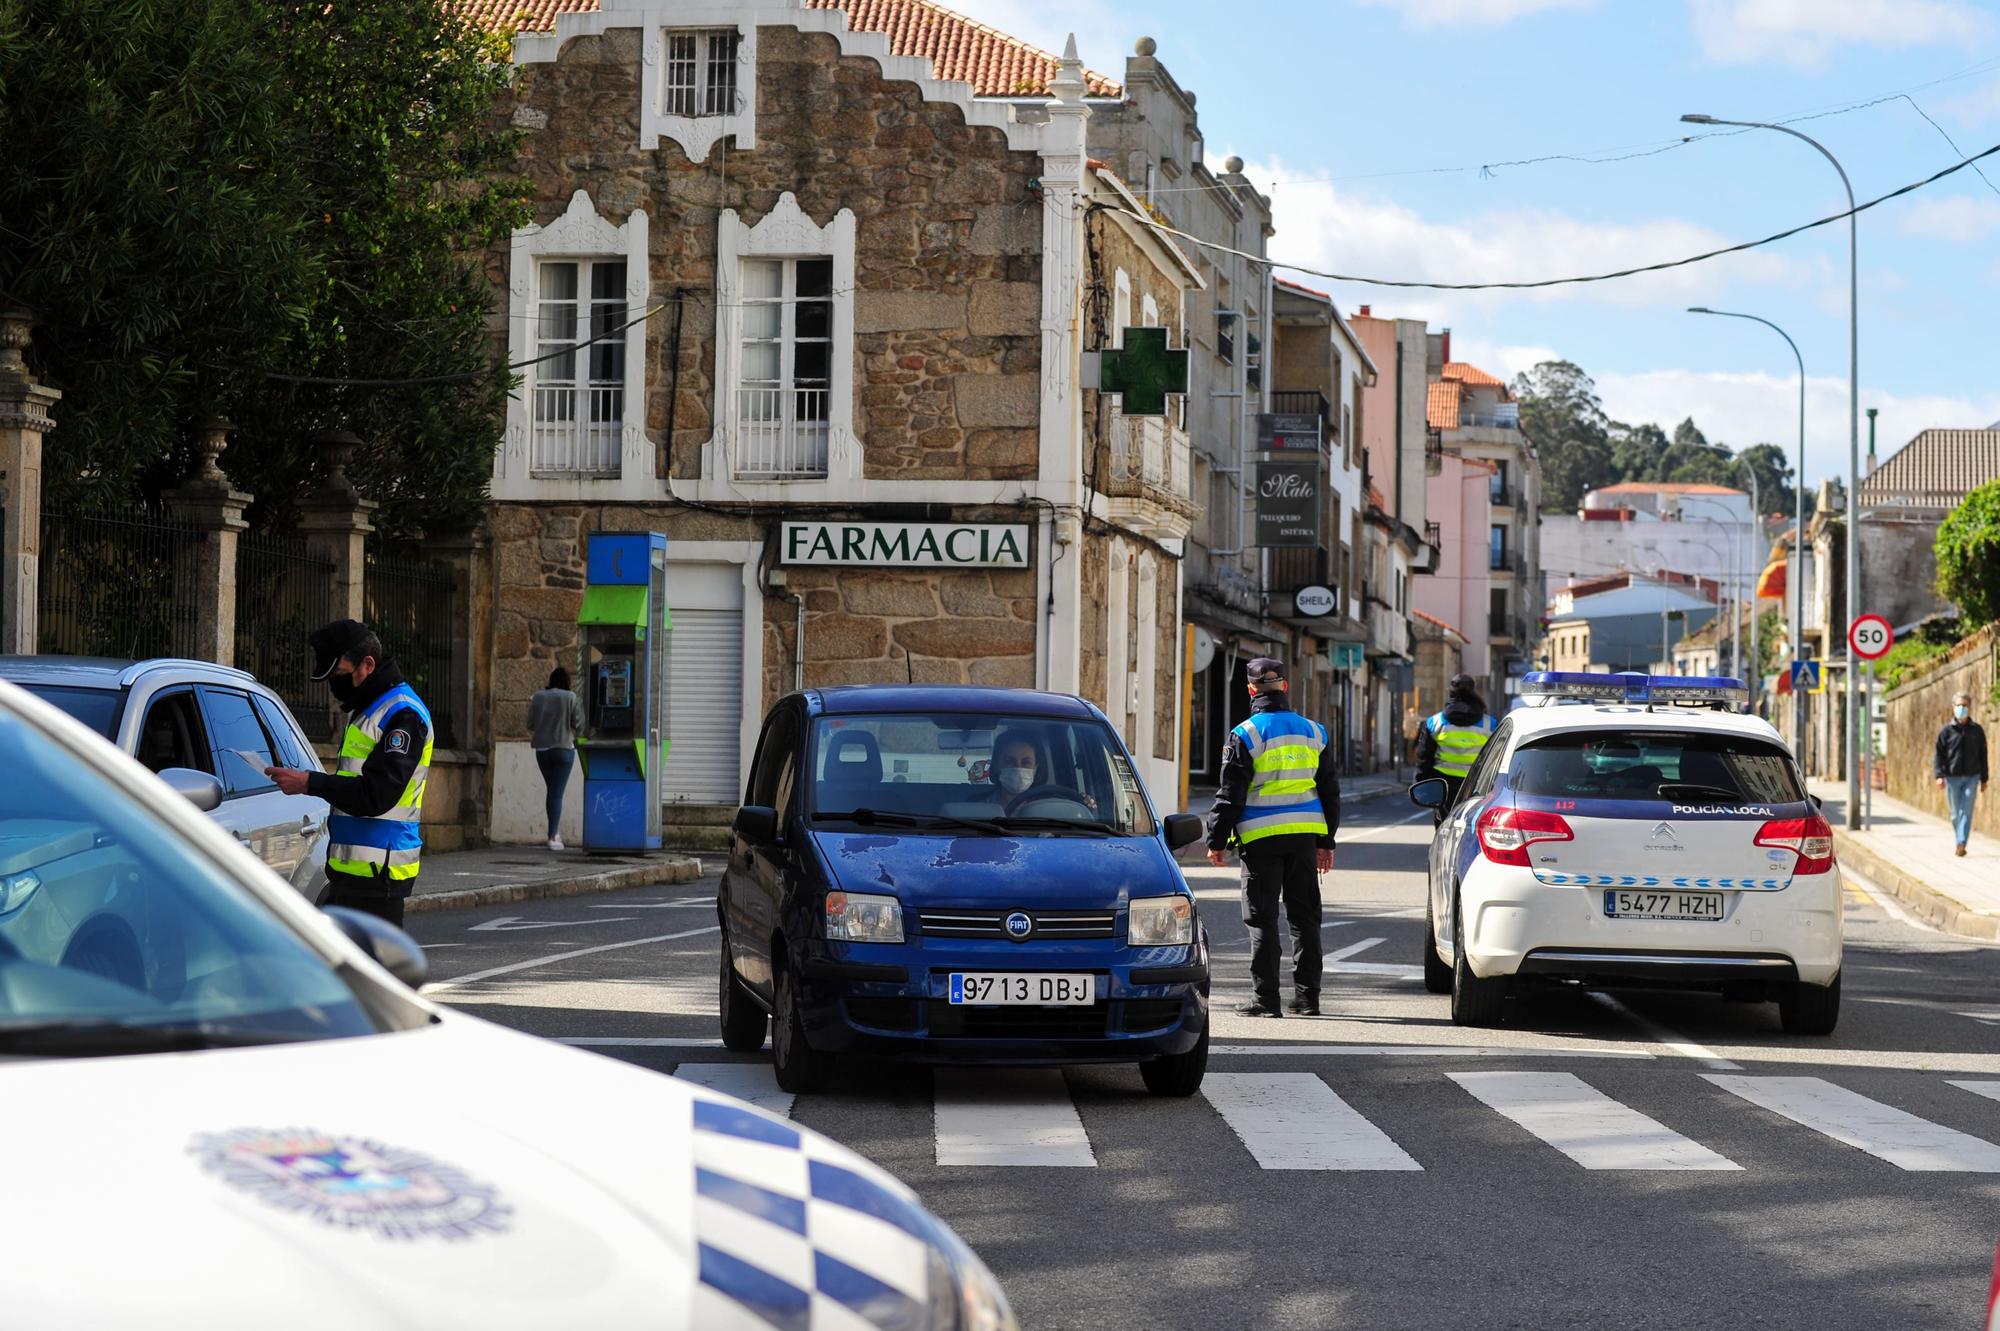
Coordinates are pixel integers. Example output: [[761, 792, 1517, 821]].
[[1508, 729, 1806, 803]]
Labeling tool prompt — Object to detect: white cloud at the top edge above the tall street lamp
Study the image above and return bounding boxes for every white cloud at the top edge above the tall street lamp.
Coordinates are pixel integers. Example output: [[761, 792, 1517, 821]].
[[1690, 0, 1990, 66]]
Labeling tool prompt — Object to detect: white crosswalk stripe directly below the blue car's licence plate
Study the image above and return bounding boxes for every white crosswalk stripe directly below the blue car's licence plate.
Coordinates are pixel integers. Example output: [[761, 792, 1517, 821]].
[[932, 1067, 1098, 1169]]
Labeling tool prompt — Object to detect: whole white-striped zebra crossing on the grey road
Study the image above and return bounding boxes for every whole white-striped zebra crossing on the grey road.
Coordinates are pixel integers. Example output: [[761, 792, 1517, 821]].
[[674, 1061, 2000, 1173]]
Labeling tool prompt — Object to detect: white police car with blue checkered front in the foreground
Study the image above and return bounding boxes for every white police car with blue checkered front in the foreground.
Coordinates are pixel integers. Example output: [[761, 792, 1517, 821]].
[[0, 683, 1014, 1331]]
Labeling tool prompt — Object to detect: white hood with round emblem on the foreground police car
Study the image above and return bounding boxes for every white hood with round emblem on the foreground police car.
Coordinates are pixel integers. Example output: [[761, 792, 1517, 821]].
[[0, 1015, 936, 1331]]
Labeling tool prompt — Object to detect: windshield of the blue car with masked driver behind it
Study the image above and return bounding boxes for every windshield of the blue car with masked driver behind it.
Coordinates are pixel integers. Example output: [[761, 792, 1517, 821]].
[[812, 713, 1154, 837]]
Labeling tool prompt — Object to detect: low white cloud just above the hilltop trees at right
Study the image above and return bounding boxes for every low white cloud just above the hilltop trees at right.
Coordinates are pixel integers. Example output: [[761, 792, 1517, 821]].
[[1594, 365, 2000, 486]]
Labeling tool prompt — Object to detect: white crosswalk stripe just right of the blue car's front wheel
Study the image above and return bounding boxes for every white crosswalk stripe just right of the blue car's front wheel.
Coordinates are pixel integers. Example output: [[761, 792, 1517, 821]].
[[1202, 1073, 1422, 1169]]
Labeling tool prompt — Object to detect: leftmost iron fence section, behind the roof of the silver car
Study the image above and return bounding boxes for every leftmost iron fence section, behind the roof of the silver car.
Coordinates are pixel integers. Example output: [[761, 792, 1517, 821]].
[[36, 512, 202, 662]]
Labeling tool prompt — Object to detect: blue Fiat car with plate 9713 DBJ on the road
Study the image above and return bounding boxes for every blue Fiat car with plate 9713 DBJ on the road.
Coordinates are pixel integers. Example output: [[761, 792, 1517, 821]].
[[716, 685, 1208, 1095]]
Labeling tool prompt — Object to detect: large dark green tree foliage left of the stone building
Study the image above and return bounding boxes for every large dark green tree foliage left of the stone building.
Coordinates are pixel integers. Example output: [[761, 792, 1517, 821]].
[[0, 0, 526, 532]]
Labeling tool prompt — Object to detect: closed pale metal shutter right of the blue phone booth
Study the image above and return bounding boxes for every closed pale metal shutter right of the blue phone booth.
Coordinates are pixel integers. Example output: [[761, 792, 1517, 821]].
[[666, 607, 752, 803]]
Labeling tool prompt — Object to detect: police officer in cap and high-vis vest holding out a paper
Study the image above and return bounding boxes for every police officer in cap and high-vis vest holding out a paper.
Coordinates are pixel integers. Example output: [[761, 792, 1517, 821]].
[[268, 620, 430, 925]]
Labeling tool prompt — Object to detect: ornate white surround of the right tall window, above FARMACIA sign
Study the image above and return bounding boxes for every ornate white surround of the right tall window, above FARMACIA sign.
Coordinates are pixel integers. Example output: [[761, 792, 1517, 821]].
[[702, 192, 862, 487]]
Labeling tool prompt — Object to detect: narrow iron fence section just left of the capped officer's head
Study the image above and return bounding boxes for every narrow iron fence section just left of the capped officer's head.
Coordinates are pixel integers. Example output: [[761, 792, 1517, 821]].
[[236, 534, 336, 741]]
